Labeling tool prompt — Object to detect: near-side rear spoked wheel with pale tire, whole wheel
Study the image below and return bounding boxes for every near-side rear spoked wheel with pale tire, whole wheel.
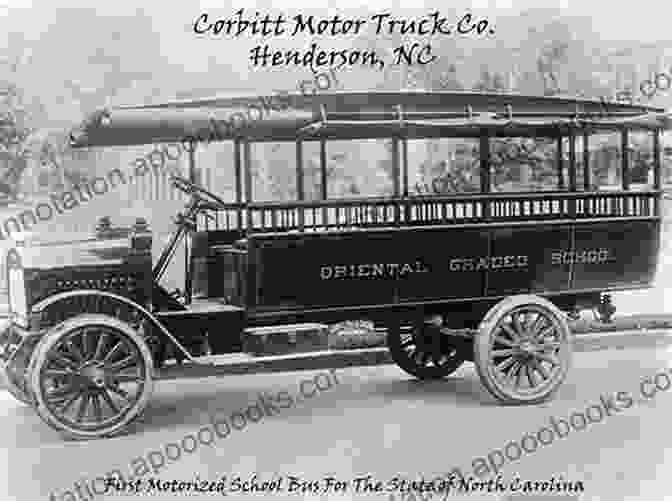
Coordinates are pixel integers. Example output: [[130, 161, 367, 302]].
[[474, 295, 572, 404]]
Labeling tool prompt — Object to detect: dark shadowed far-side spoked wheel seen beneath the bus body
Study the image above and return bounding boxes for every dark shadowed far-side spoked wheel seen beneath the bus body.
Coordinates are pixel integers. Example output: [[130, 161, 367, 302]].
[[387, 320, 465, 379]]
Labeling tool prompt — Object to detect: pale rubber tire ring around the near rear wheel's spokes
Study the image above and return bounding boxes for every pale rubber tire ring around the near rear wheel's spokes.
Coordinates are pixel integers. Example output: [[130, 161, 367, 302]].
[[474, 295, 572, 405]]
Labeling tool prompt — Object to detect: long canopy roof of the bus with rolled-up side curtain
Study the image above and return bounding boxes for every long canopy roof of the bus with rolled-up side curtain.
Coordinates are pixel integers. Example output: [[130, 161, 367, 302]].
[[70, 91, 672, 147]]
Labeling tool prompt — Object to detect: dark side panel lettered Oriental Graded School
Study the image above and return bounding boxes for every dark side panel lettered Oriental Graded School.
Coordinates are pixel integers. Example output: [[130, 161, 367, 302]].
[[248, 221, 658, 311]]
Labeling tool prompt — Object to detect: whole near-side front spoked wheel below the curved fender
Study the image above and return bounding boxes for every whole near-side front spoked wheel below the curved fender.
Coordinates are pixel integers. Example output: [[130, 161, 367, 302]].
[[29, 314, 153, 439]]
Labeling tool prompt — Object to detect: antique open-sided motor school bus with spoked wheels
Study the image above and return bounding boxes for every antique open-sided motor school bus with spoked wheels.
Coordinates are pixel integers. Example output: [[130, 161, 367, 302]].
[[1, 92, 669, 438]]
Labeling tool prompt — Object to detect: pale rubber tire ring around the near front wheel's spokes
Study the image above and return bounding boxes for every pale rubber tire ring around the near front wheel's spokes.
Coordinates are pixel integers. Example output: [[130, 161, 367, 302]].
[[29, 314, 154, 440]]
